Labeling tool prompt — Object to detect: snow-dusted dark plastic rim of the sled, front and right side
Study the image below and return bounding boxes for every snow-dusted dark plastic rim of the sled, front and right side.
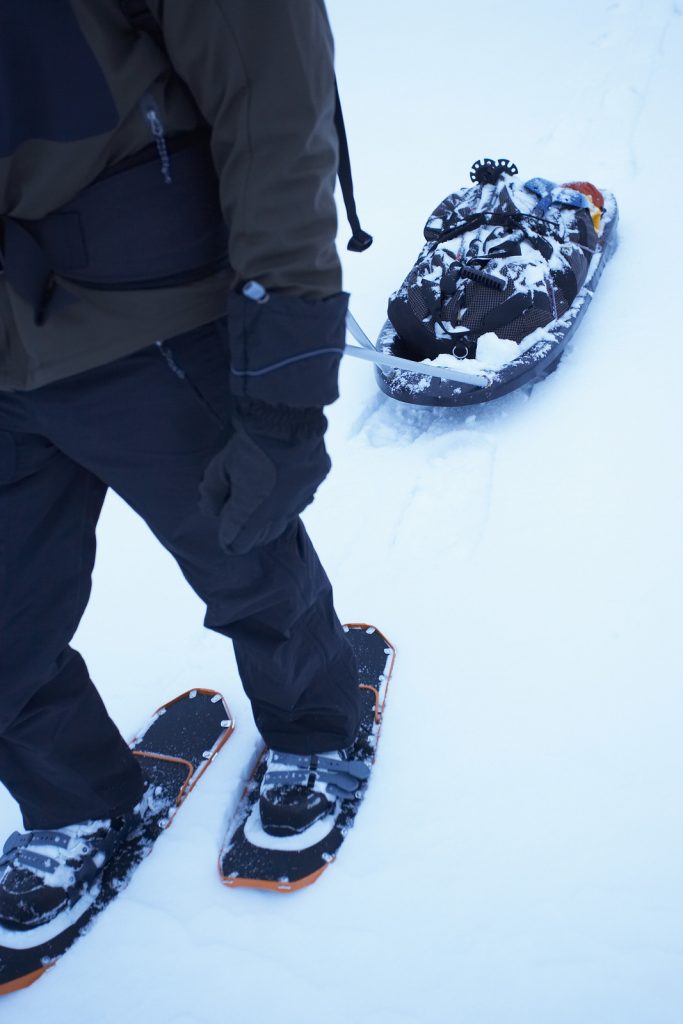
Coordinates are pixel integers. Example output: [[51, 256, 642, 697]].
[[375, 189, 618, 406]]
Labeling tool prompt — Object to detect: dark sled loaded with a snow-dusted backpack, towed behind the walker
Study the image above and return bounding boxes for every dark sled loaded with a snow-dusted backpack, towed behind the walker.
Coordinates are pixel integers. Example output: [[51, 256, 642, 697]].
[[347, 159, 618, 406]]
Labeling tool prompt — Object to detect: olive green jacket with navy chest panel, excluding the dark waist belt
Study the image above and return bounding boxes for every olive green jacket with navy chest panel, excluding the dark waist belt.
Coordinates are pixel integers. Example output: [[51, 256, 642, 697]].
[[0, 0, 341, 390]]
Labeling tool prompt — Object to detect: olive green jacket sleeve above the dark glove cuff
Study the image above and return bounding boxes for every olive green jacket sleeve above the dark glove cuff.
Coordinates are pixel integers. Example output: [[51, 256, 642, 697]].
[[150, 0, 341, 299]]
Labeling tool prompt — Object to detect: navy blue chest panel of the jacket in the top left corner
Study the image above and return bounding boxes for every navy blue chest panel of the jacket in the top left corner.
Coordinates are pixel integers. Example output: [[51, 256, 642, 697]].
[[0, 0, 119, 158]]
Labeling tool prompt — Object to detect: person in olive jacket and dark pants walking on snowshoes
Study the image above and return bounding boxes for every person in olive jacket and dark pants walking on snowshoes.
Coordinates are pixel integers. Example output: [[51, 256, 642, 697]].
[[0, 0, 366, 929]]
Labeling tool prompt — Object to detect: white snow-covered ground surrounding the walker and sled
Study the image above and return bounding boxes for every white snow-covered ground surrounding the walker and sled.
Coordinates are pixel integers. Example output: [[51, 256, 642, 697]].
[[0, 0, 683, 1024]]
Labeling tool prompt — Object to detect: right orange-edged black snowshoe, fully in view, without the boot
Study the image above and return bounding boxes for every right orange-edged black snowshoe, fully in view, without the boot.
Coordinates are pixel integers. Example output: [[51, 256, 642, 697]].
[[219, 625, 394, 892]]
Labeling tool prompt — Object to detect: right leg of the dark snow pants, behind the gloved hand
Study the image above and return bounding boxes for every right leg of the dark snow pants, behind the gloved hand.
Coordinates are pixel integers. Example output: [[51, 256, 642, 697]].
[[36, 322, 359, 753]]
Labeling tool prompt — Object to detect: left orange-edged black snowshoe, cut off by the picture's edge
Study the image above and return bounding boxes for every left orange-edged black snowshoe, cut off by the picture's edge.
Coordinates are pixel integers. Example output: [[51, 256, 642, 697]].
[[0, 689, 233, 995]]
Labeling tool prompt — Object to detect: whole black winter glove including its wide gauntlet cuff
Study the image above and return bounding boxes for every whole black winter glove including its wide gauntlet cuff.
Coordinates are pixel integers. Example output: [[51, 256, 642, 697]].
[[200, 282, 348, 555]]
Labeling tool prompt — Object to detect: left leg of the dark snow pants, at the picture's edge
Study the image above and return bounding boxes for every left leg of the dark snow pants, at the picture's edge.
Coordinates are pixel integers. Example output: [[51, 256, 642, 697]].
[[0, 419, 141, 828]]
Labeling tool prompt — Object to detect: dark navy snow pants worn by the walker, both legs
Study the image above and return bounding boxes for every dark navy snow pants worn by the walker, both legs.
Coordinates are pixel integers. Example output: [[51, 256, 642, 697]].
[[0, 321, 358, 828]]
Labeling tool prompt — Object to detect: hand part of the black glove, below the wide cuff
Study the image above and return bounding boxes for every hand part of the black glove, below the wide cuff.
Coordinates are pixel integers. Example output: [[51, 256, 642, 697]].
[[200, 399, 331, 555]]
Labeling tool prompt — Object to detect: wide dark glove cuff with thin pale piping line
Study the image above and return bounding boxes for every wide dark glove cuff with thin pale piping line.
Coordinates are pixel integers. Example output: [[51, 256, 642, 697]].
[[227, 292, 348, 410]]
